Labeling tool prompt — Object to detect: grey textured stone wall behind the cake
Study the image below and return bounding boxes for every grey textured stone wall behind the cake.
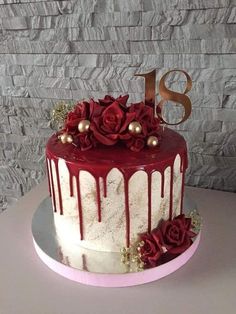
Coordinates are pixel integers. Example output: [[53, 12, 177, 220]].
[[0, 0, 236, 209]]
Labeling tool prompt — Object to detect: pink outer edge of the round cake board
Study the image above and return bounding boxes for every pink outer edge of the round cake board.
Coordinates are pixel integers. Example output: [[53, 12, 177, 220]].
[[33, 232, 201, 287]]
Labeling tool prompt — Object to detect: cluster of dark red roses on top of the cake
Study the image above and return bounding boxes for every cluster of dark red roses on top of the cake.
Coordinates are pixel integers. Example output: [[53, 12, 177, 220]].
[[61, 95, 160, 152]]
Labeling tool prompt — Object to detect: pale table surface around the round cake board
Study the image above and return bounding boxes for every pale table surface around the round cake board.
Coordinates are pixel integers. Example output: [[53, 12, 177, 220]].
[[0, 182, 236, 314]]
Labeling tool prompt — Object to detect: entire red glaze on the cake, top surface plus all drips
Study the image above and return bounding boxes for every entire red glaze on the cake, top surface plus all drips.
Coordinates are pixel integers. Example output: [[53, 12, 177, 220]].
[[46, 128, 187, 247]]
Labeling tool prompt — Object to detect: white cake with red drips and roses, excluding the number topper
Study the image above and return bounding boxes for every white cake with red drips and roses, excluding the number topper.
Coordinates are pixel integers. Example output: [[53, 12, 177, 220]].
[[46, 70, 200, 267]]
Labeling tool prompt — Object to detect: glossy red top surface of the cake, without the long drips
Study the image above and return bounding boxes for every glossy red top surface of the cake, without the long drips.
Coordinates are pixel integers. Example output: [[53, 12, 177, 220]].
[[47, 127, 186, 170]]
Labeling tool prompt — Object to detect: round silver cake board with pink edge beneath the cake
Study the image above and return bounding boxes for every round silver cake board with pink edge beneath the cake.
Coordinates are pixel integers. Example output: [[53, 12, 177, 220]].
[[32, 197, 200, 287]]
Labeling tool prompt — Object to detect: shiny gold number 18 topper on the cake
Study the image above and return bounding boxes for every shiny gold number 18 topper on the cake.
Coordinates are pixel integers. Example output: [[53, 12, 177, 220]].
[[135, 69, 192, 125]]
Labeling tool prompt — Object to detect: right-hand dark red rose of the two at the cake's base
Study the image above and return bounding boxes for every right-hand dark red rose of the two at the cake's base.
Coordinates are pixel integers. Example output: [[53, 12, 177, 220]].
[[159, 214, 196, 254]]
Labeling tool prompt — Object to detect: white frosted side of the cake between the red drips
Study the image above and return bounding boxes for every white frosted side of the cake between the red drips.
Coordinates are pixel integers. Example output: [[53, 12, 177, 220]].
[[47, 155, 182, 252]]
